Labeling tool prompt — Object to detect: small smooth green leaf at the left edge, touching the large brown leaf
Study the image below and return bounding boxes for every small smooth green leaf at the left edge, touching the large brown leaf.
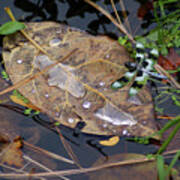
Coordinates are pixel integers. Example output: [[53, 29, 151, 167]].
[[0, 21, 25, 35]]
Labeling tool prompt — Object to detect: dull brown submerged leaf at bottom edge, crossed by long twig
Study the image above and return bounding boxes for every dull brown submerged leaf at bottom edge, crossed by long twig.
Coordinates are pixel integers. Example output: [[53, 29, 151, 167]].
[[88, 153, 180, 180]]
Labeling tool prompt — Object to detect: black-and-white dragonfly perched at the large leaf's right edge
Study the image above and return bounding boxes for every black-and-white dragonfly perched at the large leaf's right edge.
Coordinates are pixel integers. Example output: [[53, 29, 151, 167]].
[[111, 42, 167, 96]]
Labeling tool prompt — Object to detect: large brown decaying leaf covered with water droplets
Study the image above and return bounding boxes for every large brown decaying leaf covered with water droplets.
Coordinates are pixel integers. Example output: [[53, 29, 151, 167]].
[[3, 22, 156, 136]]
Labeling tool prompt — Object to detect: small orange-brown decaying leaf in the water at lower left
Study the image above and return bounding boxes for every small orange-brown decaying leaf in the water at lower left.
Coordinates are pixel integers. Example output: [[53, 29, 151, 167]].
[[0, 137, 23, 167]]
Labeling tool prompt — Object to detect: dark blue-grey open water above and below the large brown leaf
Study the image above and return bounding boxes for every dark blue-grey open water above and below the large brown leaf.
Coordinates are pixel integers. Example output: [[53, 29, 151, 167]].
[[0, 0, 179, 180]]
